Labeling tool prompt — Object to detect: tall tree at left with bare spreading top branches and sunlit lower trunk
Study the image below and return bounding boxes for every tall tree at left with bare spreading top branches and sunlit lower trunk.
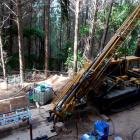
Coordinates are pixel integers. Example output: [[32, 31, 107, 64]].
[[3, 0, 33, 85]]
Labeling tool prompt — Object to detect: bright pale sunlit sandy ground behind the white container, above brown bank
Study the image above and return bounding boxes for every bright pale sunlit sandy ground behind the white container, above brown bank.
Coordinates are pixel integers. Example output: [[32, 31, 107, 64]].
[[0, 75, 69, 100]]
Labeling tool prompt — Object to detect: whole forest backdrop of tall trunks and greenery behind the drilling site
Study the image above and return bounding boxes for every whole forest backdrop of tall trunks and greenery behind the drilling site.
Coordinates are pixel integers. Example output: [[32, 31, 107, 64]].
[[0, 0, 140, 83]]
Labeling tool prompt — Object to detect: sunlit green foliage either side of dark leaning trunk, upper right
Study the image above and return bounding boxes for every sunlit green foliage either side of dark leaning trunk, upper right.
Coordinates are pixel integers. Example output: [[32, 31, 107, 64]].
[[93, 3, 136, 41]]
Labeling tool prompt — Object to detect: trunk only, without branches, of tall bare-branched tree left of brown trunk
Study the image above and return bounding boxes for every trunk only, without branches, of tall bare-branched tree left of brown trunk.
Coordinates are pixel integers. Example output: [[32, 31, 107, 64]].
[[16, 0, 24, 85]]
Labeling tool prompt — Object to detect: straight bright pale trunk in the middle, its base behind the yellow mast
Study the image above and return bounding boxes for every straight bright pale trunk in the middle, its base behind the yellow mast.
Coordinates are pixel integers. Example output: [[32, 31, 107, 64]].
[[73, 0, 80, 72]]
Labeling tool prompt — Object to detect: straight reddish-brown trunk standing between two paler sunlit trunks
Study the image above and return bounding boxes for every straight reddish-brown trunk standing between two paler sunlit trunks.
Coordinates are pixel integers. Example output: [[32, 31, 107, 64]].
[[45, 0, 50, 78]]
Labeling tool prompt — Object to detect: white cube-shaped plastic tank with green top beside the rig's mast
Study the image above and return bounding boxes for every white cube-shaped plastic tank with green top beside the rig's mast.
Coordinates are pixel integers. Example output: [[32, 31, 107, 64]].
[[33, 84, 53, 105]]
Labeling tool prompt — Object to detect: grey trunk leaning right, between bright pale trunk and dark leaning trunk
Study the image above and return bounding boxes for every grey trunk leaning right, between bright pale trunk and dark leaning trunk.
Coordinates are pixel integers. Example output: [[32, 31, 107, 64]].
[[89, 0, 99, 60]]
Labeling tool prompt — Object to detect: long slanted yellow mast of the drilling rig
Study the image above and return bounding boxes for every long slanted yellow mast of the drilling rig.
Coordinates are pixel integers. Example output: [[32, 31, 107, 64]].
[[52, 4, 140, 117]]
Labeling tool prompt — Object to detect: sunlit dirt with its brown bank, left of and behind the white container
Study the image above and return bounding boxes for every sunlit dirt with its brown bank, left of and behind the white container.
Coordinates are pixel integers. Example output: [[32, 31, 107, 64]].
[[0, 75, 69, 113]]
